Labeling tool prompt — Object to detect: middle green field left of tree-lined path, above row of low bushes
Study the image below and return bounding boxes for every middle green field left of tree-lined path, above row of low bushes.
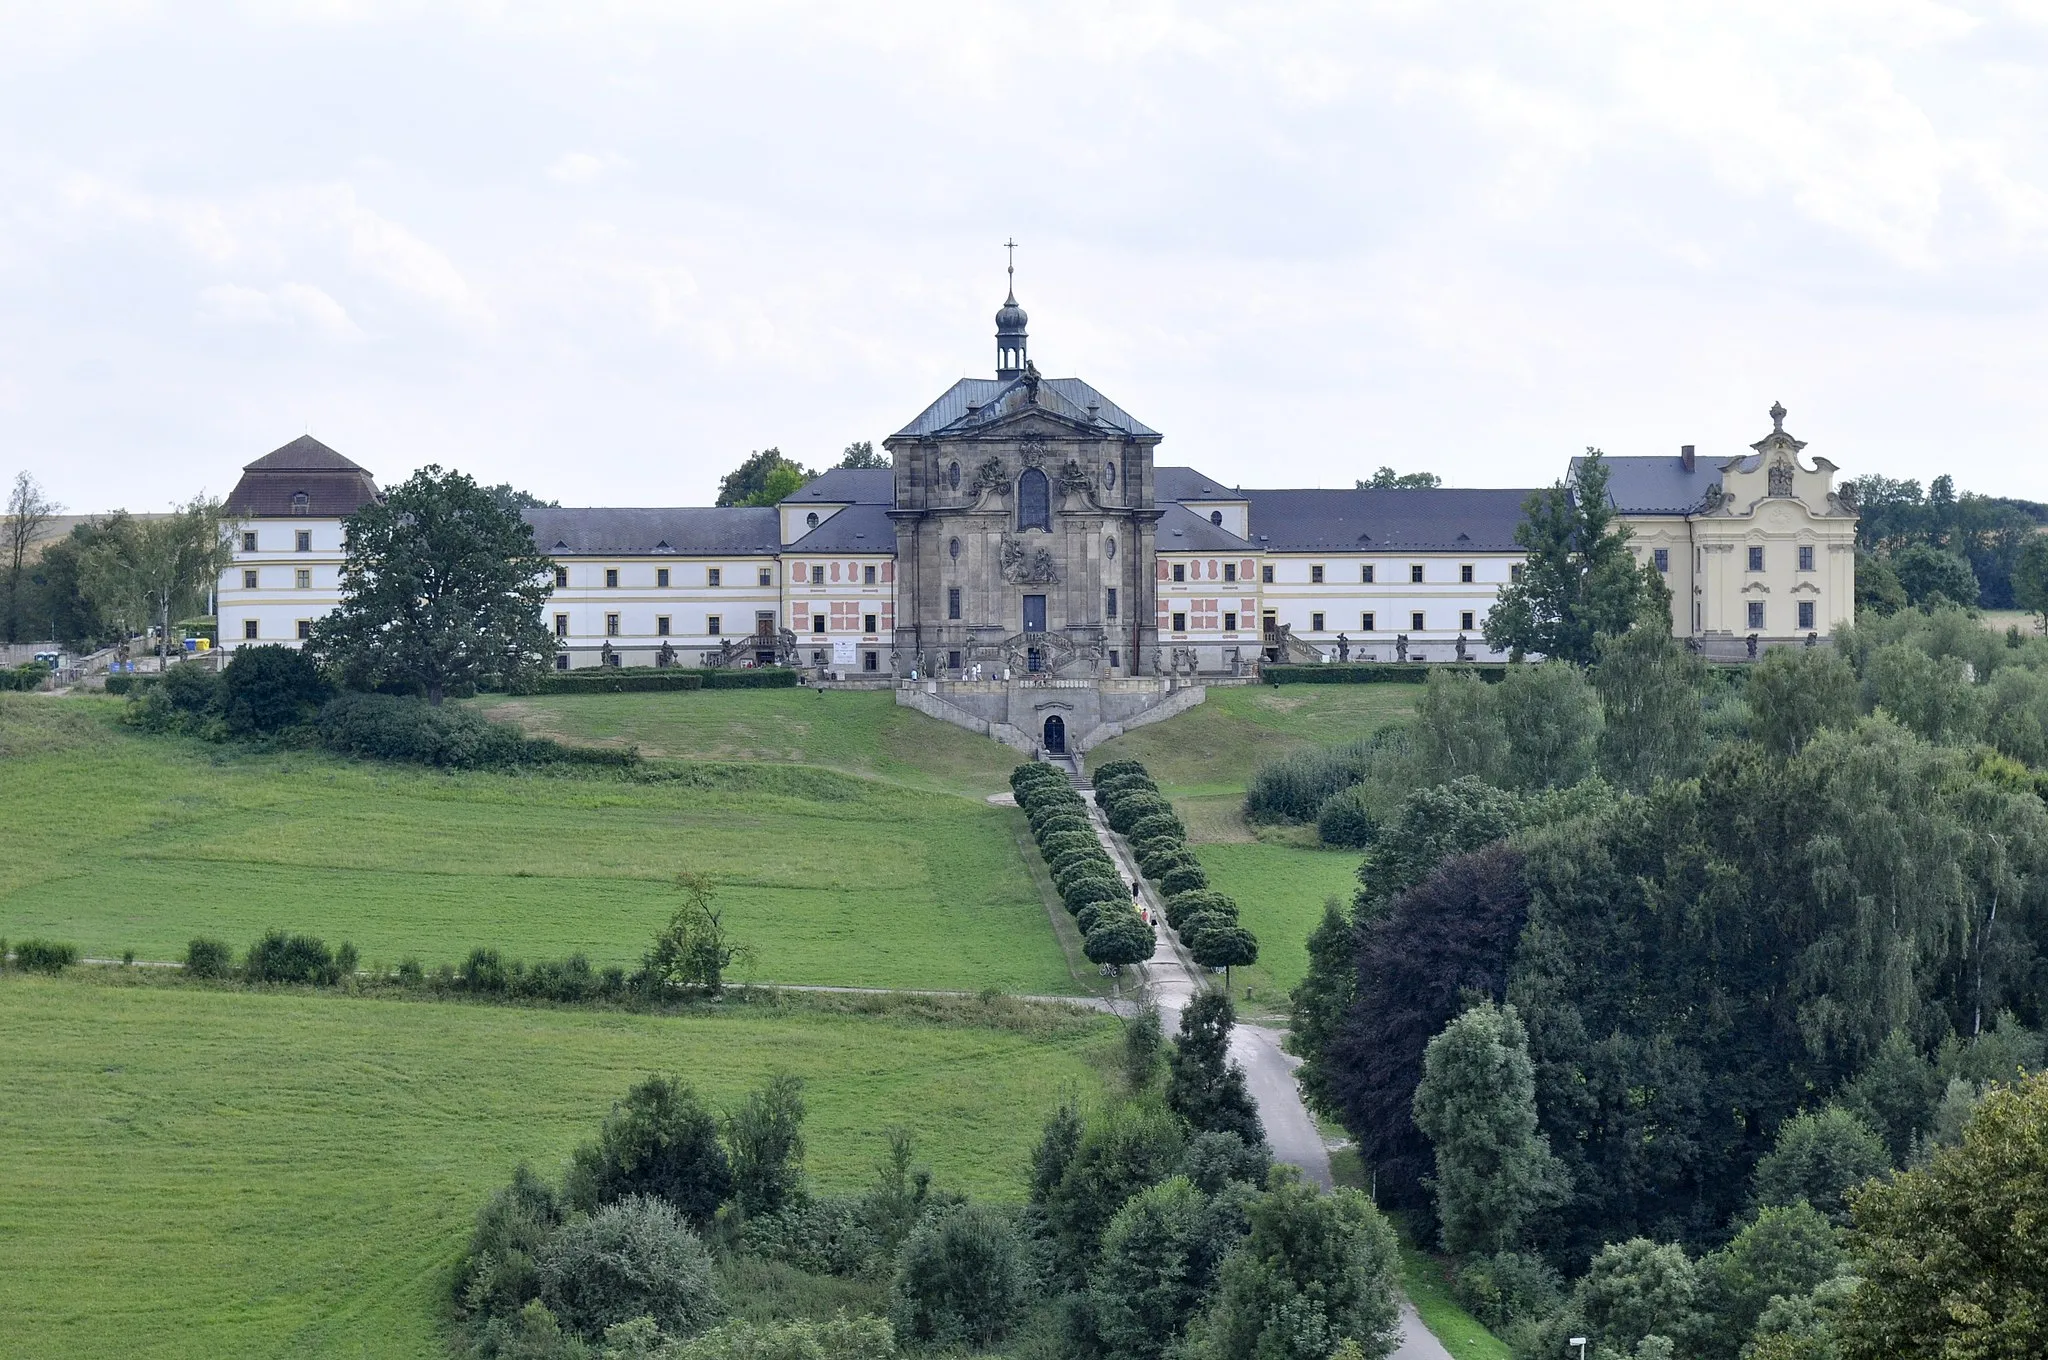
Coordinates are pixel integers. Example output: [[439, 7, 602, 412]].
[[0, 692, 1083, 993]]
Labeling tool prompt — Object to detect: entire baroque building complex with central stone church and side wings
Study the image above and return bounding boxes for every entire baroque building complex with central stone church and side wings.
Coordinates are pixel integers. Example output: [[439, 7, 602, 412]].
[[219, 278, 1855, 739]]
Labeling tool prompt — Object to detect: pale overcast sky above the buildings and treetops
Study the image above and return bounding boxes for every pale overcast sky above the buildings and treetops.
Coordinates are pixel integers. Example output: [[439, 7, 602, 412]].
[[0, 0, 2048, 510]]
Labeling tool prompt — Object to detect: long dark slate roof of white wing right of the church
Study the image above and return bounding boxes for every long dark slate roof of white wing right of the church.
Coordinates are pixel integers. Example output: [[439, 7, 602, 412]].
[[1243, 487, 1530, 553]]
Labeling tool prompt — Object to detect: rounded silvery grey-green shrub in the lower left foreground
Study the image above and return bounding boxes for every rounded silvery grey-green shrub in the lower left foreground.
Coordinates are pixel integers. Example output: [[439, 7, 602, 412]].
[[539, 1194, 723, 1342]]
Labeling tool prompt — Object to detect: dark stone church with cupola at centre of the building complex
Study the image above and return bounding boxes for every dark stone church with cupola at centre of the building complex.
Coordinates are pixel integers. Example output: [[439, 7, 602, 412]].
[[883, 270, 1161, 680]]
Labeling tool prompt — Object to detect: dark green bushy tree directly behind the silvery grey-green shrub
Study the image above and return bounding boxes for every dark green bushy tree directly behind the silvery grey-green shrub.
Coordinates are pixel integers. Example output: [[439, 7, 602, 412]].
[[561, 1075, 733, 1225]]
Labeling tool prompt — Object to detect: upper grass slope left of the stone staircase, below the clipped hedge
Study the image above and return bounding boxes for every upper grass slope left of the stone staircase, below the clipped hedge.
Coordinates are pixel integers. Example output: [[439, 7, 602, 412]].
[[477, 690, 1018, 797]]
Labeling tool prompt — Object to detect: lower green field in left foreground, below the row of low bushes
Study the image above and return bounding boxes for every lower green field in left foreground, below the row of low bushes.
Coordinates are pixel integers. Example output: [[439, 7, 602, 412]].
[[0, 973, 1114, 1360]]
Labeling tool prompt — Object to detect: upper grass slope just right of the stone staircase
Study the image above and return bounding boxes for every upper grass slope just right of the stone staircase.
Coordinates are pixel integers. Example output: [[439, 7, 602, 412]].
[[1087, 684, 1421, 797]]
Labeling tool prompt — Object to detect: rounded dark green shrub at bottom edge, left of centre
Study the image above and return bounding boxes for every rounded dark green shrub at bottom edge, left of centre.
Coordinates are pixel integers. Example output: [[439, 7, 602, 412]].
[[893, 1204, 1030, 1348]]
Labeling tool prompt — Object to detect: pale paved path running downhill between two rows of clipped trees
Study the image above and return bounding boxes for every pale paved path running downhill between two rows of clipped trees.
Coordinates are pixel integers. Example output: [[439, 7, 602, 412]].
[[1085, 795, 1452, 1360]]
